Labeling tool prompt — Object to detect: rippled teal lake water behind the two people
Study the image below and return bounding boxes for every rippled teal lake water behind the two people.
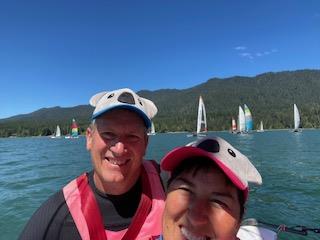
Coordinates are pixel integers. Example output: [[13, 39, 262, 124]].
[[0, 130, 320, 240]]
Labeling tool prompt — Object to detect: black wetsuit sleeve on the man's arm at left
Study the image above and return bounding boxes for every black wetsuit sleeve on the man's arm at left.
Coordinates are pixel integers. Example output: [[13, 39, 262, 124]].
[[19, 191, 75, 240]]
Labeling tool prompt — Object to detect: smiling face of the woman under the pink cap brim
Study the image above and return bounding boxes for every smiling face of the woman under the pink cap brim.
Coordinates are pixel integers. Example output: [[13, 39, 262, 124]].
[[163, 168, 240, 240]]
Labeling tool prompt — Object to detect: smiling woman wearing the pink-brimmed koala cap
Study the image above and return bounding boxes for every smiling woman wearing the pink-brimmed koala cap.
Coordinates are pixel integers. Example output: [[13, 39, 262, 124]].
[[160, 137, 262, 240]]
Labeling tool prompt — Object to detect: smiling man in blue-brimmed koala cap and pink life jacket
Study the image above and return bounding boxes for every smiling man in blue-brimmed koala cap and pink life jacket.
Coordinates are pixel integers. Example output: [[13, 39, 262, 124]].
[[20, 89, 165, 240]]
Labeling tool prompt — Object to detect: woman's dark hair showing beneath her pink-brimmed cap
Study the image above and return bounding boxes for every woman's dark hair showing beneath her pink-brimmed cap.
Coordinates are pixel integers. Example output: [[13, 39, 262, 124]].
[[167, 157, 245, 221]]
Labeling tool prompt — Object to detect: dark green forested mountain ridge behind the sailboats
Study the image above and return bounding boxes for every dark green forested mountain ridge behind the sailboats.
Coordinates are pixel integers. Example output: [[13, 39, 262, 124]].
[[0, 70, 320, 136]]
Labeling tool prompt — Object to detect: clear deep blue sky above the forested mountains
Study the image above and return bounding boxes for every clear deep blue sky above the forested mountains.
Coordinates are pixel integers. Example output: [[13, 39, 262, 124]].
[[0, 0, 320, 118]]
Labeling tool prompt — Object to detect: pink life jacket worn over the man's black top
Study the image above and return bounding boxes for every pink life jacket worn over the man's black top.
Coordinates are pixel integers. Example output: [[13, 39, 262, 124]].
[[63, 161, 165, 240]]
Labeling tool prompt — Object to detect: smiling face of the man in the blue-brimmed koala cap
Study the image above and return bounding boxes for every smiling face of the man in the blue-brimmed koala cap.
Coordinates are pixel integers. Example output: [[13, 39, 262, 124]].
[[87, 109, 148, 195]]
